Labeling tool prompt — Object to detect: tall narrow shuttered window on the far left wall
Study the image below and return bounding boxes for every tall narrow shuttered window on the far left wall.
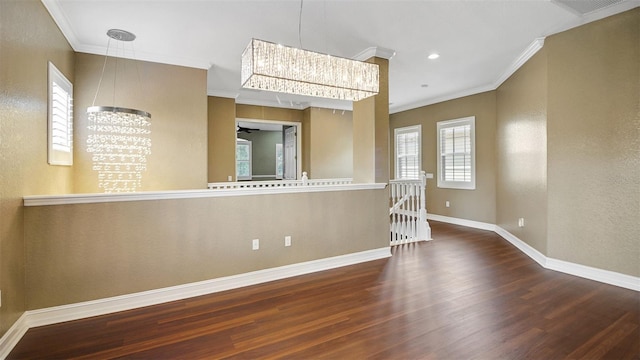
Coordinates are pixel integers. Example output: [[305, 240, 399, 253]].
[[47, 62, 73, 165]]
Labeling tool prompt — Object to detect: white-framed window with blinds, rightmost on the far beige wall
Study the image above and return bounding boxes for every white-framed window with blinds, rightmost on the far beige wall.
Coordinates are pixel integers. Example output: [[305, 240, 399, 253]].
[[437, 116, 476, 190]]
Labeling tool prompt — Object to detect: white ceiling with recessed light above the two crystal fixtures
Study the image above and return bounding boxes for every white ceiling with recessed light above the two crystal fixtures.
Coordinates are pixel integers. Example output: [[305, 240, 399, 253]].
[[42, 0, 640, 113]]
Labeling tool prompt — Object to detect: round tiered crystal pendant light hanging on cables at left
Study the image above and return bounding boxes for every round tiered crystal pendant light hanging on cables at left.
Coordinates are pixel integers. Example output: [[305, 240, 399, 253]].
[[87, 29, 151, 193]]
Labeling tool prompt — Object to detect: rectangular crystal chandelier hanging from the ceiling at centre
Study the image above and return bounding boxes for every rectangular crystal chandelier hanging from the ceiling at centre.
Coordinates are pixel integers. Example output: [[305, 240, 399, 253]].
[[241, 39, 379, 101]]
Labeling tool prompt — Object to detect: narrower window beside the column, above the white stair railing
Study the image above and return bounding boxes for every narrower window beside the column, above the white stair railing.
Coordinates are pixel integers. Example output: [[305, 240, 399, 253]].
[[393, 125, 422, 179]]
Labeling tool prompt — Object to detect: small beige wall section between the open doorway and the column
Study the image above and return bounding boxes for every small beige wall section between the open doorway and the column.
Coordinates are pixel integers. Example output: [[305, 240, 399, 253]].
[[303, 108, 354, 179]]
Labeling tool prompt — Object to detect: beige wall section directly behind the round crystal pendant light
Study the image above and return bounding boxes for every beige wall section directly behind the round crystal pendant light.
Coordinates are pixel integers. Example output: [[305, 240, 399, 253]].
[[74, 52, 207, 193]]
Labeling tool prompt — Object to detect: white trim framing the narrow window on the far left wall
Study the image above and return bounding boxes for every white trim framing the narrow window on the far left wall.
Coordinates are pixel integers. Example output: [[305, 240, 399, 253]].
[[47, 61, 73, 166]]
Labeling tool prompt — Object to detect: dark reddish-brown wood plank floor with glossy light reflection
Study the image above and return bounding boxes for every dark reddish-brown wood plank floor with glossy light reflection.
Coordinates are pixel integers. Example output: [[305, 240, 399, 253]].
[[9, 222, 640, 359]]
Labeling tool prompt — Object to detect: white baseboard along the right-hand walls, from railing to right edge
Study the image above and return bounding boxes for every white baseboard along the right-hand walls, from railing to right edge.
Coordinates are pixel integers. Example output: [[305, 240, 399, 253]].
[[427, 214, 640, 291]]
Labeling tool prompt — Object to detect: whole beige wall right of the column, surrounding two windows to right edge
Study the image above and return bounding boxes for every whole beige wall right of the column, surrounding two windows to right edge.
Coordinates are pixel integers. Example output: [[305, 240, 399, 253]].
[[390, 8, 640, 276]]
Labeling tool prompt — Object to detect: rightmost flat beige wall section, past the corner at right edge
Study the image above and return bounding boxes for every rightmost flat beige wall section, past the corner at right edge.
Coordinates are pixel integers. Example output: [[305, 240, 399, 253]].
[[545, 8, 640, 276]]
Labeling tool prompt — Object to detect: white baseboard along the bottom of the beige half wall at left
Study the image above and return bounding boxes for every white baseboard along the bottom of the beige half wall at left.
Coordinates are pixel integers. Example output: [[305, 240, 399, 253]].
[[0, 247, 391, 359]]
